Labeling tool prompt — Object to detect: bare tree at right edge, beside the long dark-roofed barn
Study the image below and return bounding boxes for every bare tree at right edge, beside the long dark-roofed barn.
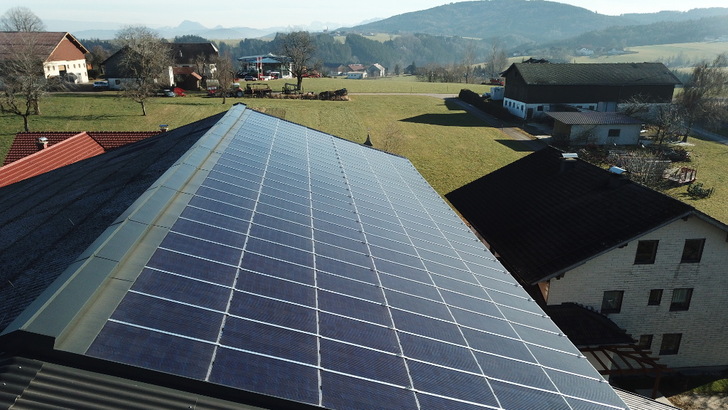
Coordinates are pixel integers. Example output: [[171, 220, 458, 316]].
[[676, 54, 728, 141]]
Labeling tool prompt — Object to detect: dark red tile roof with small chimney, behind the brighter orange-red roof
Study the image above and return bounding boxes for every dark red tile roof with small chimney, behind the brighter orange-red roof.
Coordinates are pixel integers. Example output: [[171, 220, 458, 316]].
[[3, 131, 159, 165]]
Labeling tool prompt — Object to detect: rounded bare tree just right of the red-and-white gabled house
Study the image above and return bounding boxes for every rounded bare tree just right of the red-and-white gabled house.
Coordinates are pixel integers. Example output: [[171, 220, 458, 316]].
[[115, 26, 172, 115]]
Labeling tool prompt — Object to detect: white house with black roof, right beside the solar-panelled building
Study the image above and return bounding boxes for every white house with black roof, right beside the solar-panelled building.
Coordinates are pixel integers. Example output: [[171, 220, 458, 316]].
[[446, 147, 728, 368]]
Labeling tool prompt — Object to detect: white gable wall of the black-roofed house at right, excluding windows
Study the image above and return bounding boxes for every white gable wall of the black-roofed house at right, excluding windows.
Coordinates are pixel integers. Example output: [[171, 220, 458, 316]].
[[547, 216, 728, 367]]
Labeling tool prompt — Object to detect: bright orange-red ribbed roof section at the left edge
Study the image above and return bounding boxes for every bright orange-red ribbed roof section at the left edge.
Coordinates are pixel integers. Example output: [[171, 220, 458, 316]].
[[0, 132, 105, 187]]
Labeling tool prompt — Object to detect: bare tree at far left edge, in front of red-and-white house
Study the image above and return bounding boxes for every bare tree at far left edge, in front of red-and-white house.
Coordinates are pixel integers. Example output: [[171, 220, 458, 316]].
[[0, 33, 48, 132]]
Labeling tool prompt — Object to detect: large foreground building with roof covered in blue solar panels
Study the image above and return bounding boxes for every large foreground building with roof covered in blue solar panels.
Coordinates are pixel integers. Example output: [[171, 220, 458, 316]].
[[0, 104, 625, 410]]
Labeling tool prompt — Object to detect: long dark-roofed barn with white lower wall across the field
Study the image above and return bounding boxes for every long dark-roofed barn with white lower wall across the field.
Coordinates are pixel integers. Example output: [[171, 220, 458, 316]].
[[502, 63, 680, 119]]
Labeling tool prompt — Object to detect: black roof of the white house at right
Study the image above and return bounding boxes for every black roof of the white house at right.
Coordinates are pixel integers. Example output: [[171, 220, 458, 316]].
[[446, 147, 698, 284]]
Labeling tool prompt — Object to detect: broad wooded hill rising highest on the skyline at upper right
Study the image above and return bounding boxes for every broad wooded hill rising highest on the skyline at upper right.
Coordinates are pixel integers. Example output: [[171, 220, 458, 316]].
[[341, 0, 728, 46]]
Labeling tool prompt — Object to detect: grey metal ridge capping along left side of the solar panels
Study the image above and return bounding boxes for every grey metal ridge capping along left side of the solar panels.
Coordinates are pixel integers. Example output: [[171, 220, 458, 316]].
[[0, 104, 250, 353]]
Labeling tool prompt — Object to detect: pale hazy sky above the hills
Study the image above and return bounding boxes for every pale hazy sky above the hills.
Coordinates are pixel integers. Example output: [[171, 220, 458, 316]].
[[5, 0, 728, 28]]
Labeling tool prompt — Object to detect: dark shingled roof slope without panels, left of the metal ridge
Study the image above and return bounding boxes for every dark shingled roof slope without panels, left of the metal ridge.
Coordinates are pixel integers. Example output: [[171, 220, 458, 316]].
[[0, 114, 222, 329]]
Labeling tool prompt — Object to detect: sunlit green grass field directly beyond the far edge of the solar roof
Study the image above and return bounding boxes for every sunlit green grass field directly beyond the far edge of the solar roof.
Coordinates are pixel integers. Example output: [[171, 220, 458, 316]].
[[0, 85, 527, 195]]
